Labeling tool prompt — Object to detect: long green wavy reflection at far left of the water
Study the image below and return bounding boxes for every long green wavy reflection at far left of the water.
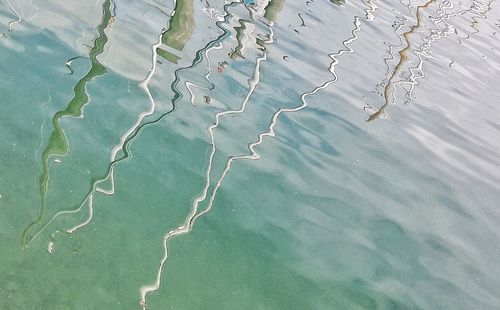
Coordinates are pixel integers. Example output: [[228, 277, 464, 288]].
[[21, 0, 112, 246]]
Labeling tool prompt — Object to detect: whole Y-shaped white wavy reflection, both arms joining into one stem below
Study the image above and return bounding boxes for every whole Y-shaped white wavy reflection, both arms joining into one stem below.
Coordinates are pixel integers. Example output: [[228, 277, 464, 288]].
[[140, 0, 378, 310]]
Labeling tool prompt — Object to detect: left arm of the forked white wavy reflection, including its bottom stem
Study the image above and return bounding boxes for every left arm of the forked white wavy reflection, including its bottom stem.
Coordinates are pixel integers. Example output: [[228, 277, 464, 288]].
[[140, 17, 274, 310]]
